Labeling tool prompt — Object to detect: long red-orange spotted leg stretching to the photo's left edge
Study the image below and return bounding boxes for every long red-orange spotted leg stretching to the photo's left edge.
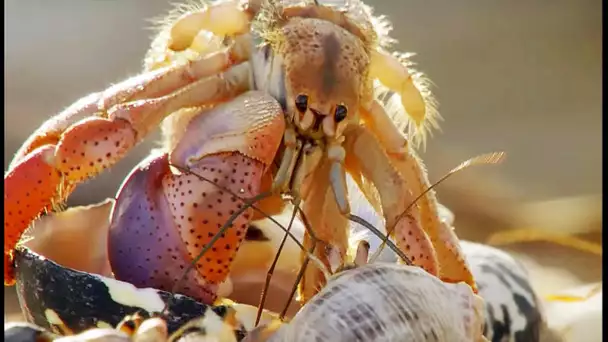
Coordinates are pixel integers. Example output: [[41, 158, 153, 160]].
[[4, 49, 249, 285]]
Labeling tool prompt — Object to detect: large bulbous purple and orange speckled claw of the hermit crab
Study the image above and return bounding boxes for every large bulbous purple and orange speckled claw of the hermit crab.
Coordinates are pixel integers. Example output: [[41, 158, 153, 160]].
[[109, 92, 285, 303]]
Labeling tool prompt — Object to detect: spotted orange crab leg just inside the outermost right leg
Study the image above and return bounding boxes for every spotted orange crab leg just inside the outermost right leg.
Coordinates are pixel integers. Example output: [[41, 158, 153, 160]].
[[344, 126, 439, 275]]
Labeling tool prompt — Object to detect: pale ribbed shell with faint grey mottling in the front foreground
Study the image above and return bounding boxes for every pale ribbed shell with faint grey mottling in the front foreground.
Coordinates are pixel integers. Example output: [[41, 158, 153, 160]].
[[270, 264, 483, 342]]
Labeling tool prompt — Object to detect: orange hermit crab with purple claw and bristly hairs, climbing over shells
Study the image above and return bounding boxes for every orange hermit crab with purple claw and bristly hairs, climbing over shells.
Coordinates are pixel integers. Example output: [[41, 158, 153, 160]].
[[4, 0, 475, 303]]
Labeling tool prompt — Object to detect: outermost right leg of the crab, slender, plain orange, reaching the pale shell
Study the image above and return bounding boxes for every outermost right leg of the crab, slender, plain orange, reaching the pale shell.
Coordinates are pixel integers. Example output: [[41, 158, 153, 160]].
[[365, 102, 477, 291]]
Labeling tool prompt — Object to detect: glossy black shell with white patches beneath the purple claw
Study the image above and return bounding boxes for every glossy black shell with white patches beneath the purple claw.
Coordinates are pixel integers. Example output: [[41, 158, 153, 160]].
[[15, 247, 275, 341]]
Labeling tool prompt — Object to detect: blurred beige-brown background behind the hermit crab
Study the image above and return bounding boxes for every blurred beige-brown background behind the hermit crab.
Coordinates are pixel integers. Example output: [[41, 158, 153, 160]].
[[4, 0, 602, 319]]
